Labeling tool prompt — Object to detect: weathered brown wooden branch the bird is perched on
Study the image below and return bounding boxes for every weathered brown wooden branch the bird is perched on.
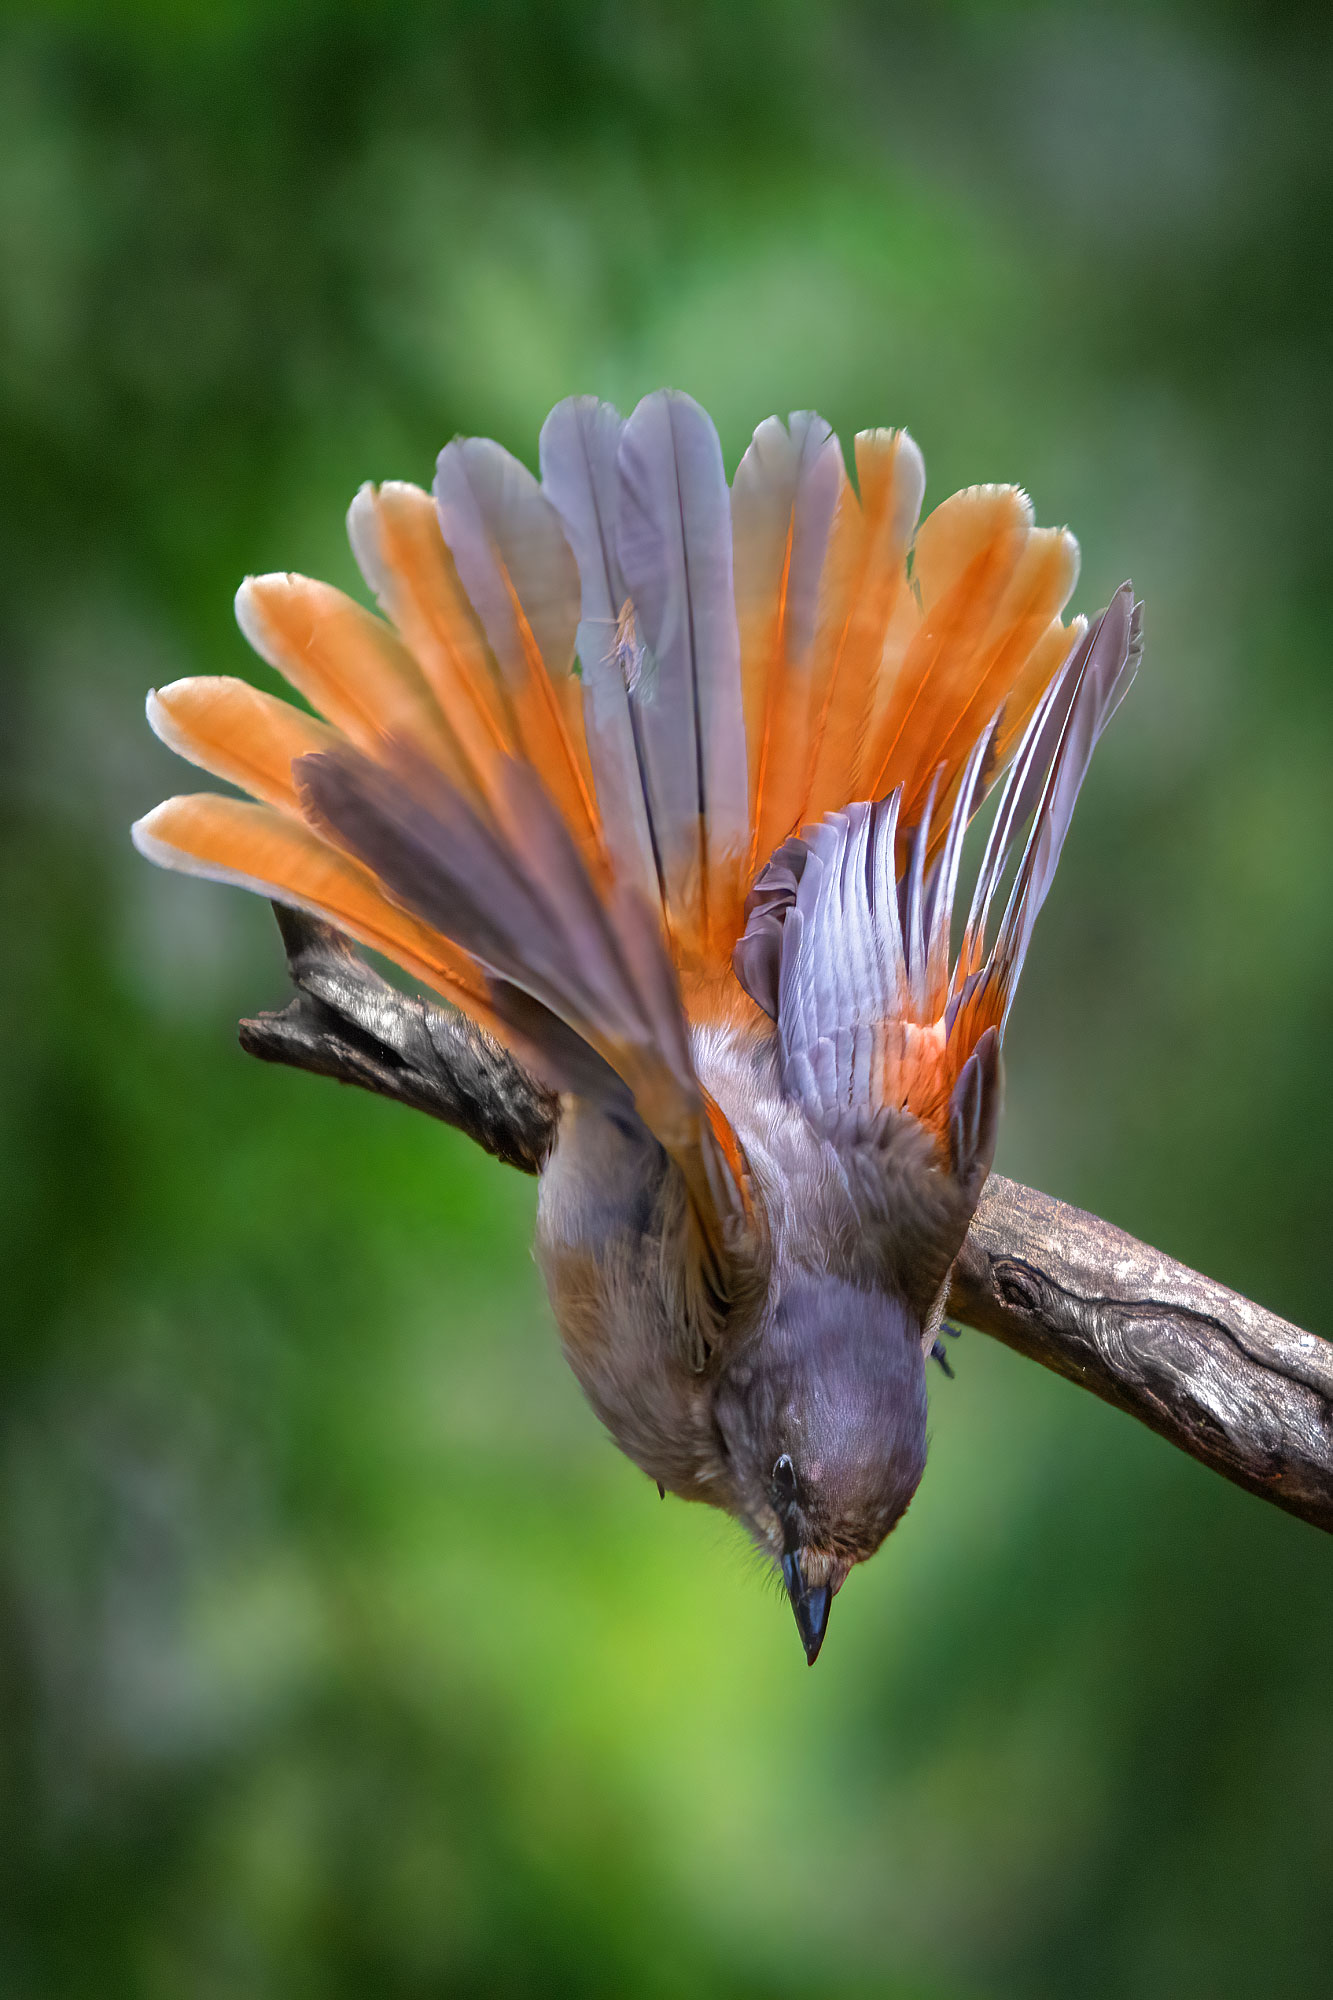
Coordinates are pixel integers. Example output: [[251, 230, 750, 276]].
[[240, 904, 1333, 1530]]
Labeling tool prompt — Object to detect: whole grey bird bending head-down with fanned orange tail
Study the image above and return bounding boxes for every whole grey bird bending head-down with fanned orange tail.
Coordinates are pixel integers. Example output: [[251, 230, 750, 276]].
[[134, 392, 1141, 1662]]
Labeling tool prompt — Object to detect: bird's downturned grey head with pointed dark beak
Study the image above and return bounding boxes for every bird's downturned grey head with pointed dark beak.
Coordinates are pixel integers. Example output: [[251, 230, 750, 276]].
[[715, 1270, 927, 1666]]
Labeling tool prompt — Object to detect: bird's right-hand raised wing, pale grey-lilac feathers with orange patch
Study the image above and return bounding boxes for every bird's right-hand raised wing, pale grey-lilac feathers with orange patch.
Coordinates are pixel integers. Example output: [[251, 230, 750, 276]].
[[737, 586, 1141, 1280]]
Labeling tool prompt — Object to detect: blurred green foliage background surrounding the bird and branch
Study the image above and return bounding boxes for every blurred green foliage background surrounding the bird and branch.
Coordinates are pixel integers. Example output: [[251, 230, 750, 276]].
[[0, 0, 1333, 2000]]
